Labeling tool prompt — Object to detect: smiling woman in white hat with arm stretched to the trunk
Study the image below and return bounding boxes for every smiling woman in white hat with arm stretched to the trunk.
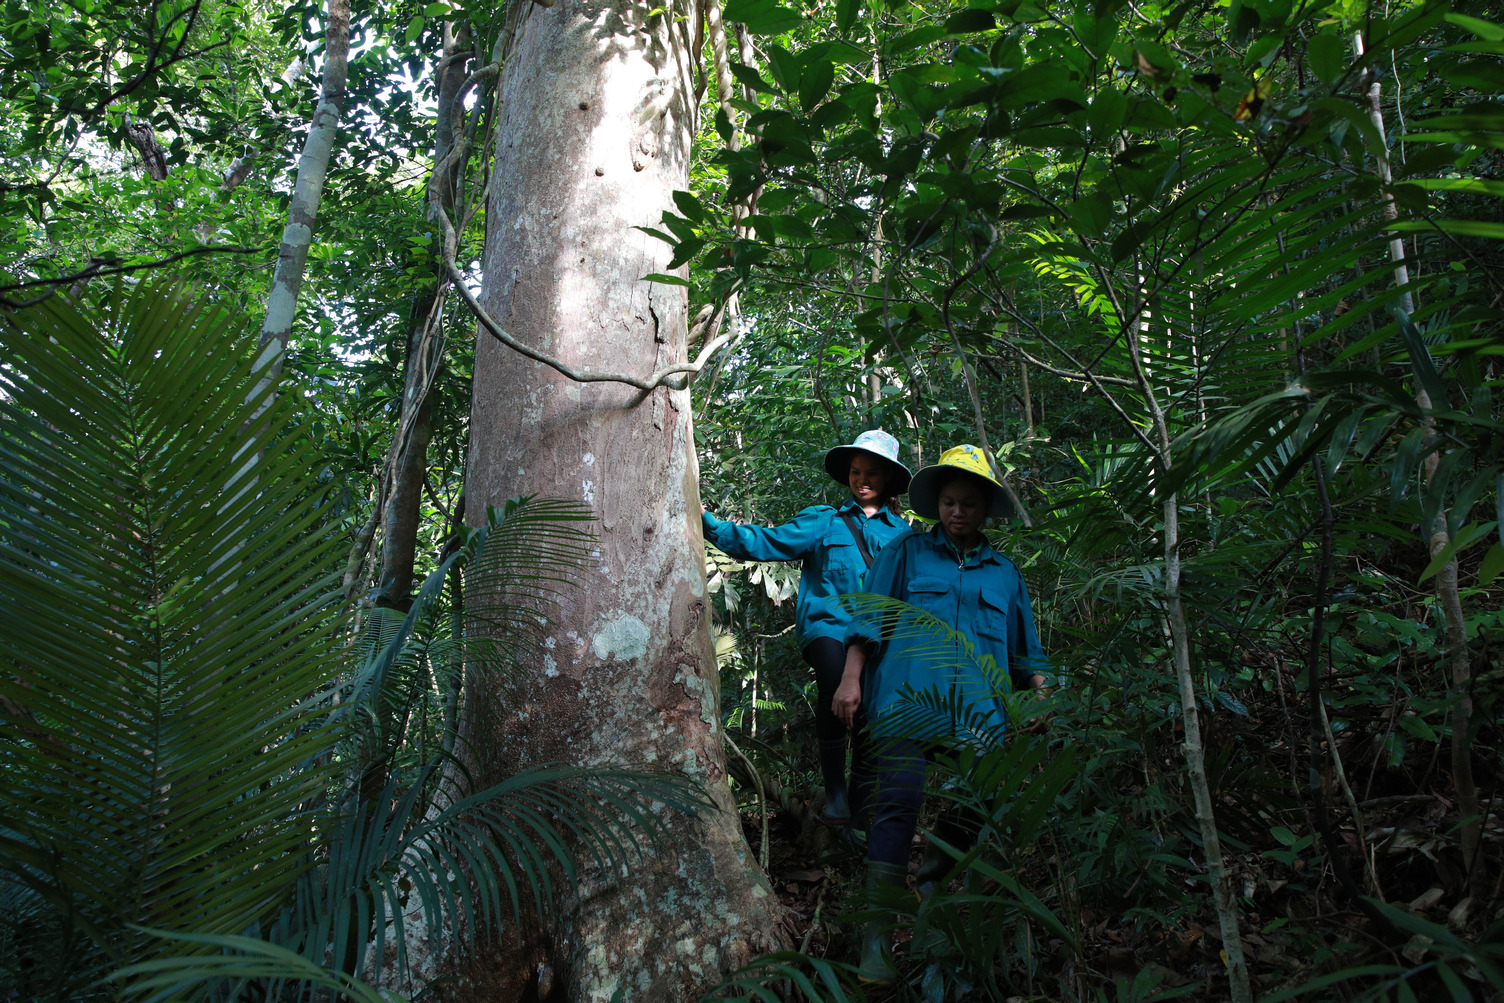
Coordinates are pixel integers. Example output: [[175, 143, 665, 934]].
[[704, 429, 908, 826]]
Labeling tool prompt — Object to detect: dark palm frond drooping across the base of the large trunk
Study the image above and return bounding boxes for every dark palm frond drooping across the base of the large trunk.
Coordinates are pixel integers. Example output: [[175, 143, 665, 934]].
[[282, 762, 711, 977]]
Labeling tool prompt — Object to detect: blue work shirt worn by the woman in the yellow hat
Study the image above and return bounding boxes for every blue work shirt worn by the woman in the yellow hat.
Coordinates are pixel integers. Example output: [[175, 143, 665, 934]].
[[847, 526, 1050, 738]]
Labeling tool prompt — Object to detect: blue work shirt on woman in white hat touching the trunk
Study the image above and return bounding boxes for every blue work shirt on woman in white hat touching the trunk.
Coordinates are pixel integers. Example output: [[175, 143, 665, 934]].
[[704, 498, 908, 650]]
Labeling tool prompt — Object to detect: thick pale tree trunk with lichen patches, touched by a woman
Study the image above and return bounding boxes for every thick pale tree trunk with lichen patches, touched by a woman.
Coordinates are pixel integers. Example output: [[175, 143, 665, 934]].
[[465, 0, 778, 1003]]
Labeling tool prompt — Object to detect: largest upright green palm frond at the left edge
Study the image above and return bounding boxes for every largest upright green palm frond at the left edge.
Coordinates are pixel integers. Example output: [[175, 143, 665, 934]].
[[0, 281, 340, 980]]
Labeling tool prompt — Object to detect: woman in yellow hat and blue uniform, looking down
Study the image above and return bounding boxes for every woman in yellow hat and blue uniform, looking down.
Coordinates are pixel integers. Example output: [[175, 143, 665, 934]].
[[833, 445, 1048, 982]]
